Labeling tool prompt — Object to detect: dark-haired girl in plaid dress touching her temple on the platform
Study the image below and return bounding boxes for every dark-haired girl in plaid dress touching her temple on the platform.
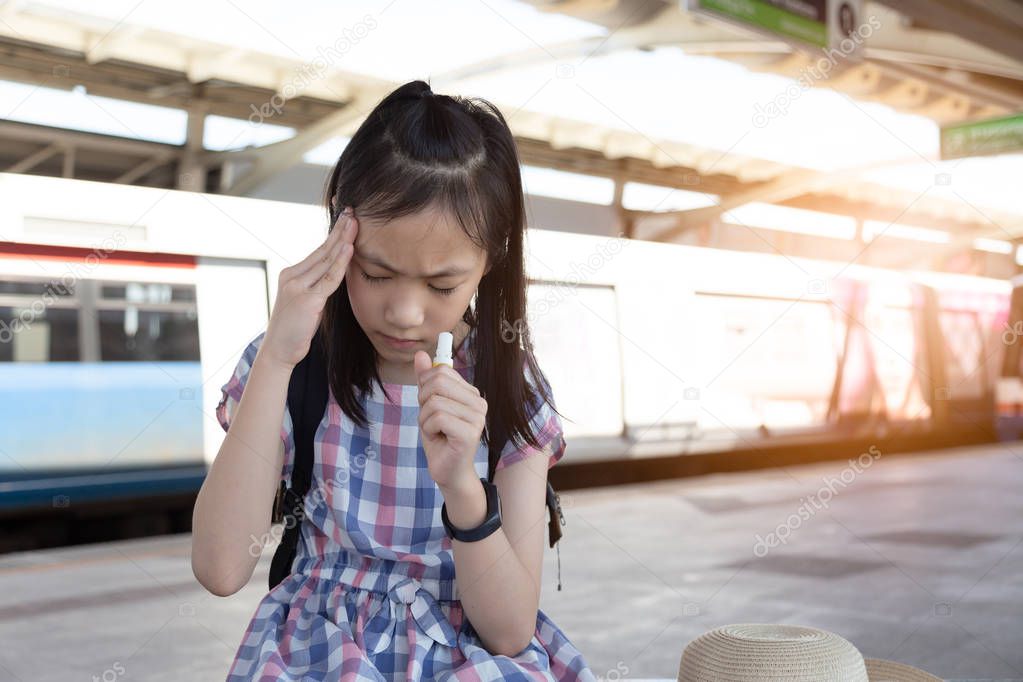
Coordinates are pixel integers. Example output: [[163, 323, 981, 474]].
[[192, 81, 595, 681]]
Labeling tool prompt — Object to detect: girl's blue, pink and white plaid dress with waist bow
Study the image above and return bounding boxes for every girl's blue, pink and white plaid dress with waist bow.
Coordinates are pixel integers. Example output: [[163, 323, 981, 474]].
[[217, 332, 596, 682]]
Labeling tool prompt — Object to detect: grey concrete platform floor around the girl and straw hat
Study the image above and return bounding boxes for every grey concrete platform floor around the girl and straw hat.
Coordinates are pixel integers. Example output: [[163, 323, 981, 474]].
[[0, 443, 1023, 682]]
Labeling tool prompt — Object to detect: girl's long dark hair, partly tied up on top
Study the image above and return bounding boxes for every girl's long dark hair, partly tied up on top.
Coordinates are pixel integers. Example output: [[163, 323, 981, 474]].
[[320, 81, 557, 465]]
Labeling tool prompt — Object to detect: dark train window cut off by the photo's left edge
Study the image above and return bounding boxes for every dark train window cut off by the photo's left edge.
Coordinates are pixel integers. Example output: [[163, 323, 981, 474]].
[[0, 304, 79, 362]]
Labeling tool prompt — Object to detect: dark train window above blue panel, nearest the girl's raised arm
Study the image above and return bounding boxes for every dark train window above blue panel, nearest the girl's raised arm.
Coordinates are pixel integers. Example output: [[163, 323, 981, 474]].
[[98, 306, 199, 362]]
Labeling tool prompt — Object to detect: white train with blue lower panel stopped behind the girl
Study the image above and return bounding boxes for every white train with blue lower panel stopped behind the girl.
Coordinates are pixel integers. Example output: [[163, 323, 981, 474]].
[[0, 174, 1023, 551]]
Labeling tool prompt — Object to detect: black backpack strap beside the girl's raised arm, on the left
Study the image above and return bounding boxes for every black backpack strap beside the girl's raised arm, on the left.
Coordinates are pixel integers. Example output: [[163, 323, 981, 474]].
[[269, 330, 328, 590]]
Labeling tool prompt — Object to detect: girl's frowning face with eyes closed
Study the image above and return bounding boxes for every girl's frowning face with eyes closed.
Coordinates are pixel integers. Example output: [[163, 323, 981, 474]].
[[345, 202, 487, 384]]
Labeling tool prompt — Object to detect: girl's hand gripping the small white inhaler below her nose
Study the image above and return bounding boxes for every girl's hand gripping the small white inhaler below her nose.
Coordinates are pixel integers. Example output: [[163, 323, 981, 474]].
[[412, 351, 487, 491]]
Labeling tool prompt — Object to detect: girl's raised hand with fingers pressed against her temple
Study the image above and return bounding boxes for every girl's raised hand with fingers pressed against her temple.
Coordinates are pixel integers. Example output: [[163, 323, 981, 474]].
[[260, 207, 359, 368]]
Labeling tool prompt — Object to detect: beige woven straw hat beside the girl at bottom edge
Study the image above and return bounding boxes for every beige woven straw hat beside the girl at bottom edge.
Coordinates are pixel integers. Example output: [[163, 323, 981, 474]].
[[678, 623, 941, 682]]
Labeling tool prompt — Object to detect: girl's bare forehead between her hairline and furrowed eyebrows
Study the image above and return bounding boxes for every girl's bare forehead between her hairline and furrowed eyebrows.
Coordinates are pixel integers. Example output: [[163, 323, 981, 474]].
[[355, 208, 484, 275]]
